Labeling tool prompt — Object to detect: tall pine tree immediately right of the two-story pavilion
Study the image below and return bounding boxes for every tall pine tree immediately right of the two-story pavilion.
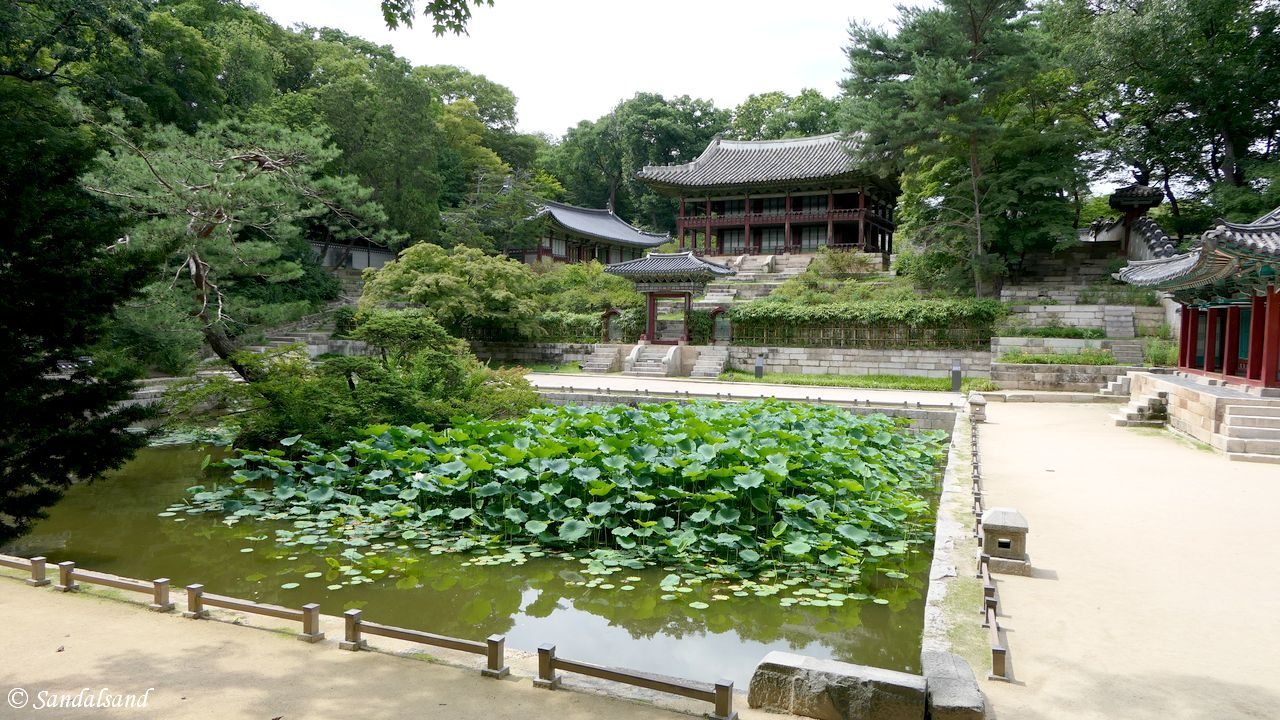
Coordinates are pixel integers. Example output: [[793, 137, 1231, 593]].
[[845, 0, 1088, 296]]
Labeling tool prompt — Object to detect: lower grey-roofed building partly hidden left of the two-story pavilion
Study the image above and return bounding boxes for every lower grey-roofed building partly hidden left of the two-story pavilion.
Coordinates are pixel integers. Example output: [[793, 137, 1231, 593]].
[[507, 200, 671, 265]]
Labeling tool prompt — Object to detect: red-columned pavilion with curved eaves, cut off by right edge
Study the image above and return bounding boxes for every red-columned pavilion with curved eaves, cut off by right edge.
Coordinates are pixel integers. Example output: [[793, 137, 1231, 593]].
[[1117, 208, 1280, 388]]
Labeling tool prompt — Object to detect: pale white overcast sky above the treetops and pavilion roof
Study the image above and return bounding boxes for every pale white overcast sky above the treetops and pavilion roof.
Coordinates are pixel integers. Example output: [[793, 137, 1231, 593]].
[[251, 0, 897, 136]]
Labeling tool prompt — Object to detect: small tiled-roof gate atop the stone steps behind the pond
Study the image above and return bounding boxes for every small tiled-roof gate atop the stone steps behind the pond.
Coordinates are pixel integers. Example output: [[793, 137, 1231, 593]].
[[604, 252, 735, 345]]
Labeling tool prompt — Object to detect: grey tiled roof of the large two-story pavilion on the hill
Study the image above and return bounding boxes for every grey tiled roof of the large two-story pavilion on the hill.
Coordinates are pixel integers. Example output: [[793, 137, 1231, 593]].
[[636, 133, 855, 188]]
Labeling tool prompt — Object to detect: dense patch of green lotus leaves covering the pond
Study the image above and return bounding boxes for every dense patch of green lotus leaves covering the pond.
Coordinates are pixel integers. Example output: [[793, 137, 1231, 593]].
[[180, 401, 946, 592]]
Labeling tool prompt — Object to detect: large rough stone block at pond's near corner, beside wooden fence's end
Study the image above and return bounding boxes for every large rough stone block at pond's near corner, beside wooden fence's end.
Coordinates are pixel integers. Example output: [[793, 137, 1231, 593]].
[[746, 651, 927, 720]]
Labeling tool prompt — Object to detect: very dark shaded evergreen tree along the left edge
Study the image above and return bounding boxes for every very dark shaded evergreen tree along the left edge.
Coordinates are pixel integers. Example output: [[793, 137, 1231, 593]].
[[0, 77, 155, 539]]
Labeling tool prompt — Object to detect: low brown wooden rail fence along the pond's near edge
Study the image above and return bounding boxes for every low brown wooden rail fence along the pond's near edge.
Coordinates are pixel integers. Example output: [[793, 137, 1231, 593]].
[[0, 555, 737, 720]]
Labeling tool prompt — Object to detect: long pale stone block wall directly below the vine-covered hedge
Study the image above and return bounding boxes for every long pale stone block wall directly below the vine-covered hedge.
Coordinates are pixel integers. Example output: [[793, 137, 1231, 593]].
[[728, 346, 991, 378]]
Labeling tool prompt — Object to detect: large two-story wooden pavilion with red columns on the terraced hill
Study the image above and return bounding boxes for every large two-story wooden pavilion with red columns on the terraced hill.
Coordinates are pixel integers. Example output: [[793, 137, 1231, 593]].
[[636, 133, 897, 261]]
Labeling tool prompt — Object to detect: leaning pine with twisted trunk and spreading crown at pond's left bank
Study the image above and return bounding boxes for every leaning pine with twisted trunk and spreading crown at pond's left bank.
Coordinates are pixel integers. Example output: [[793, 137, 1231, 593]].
[[86, 116, 385, 379]]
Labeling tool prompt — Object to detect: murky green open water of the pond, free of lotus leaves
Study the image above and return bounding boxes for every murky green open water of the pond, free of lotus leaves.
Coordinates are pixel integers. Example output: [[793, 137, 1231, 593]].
[[3, 447, 928, 688]]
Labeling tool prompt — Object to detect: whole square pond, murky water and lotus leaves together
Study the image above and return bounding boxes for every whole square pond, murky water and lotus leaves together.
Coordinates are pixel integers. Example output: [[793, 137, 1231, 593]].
[[6, 402, 943, 684]]
